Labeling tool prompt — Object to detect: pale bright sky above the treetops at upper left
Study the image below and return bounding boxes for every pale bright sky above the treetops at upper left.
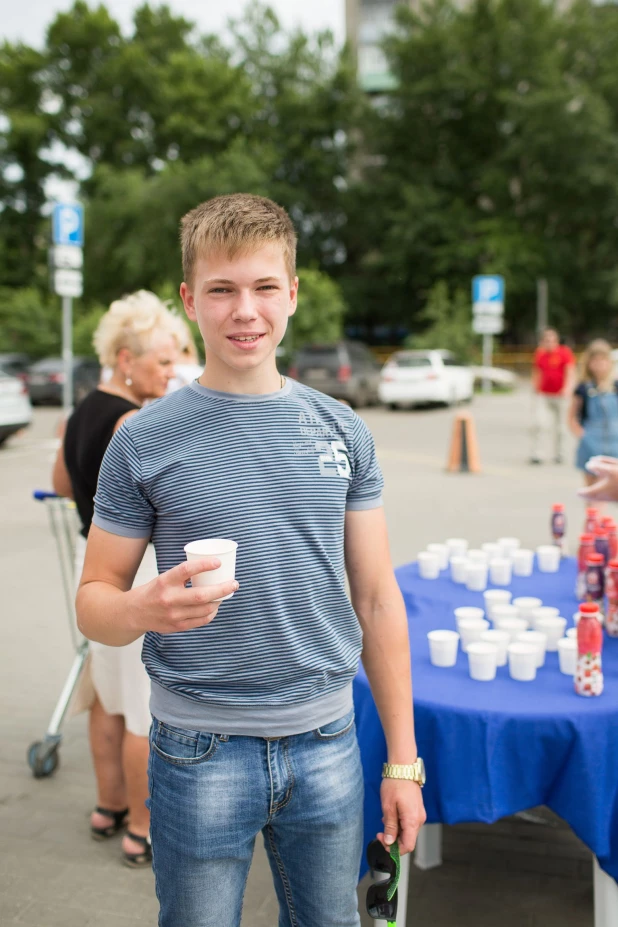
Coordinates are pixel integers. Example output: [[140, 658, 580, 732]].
[[0, 0, 345, 46]]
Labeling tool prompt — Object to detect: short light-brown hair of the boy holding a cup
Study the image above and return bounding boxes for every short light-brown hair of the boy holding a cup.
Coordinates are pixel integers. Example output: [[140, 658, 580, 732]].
[[180, 193, 296, 287]]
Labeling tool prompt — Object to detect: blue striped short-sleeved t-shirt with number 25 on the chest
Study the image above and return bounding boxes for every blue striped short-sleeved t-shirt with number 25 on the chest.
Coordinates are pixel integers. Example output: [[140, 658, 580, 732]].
[[93, 380, 383, 736]]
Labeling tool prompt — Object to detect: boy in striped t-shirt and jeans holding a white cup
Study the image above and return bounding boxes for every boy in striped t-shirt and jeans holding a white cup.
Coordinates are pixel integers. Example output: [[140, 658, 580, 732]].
[[77, 194, 425, 927]]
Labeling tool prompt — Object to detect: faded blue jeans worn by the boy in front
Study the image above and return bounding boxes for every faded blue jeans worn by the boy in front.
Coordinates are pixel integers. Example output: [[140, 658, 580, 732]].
[[149, 711, 363, 927]]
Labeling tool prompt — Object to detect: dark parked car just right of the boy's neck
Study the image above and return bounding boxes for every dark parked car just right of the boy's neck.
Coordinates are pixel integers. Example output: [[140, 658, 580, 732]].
[[289, 341, 380, 407]]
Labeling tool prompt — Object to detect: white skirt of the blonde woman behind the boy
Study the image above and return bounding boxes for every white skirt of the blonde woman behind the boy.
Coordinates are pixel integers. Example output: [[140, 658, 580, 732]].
[[70, 535, 158, 737]]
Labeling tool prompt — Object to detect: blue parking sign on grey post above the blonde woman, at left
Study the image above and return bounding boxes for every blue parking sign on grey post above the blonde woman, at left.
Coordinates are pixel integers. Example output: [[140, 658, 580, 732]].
[[51, 210, 84, 415]]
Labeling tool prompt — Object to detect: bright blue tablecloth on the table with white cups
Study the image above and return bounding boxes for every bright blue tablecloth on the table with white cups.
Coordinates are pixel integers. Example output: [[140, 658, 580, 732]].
[[354, 559, 618, 879]]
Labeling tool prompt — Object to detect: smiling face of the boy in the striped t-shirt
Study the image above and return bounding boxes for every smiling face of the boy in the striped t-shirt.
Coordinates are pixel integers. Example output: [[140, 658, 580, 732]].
[[180, 242, 298, 375]]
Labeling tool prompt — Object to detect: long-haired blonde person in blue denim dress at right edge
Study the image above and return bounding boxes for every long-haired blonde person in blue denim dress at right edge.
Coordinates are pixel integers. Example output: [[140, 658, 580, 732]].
[[569, 338, 618, 485]]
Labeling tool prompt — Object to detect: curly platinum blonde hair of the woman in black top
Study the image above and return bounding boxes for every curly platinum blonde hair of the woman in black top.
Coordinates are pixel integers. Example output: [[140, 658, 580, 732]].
[[92, 290, 182, 367]]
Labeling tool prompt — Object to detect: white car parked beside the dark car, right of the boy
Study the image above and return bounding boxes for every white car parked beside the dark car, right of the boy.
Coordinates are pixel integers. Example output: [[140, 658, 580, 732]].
[[379, 350, 474, 409]]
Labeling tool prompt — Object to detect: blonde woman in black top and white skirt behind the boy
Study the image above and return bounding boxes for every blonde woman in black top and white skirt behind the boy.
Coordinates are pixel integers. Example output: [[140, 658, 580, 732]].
[[53, 290, 179, 867]]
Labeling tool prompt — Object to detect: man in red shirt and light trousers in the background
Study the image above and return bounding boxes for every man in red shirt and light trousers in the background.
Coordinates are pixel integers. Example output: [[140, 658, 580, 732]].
[[530, 328, 575, 464]]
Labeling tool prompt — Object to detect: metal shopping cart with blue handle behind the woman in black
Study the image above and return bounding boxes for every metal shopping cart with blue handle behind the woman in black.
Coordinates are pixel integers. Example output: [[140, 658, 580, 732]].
[[28, 490, 88, 779]]
